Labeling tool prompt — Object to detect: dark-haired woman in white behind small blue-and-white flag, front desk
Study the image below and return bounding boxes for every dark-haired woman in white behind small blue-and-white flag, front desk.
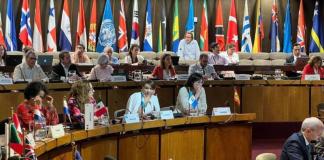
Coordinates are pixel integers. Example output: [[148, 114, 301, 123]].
[[176, 73, 207, 115]]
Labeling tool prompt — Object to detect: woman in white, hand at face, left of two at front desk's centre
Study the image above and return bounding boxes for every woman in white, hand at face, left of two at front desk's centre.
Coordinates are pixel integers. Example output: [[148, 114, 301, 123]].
[[126, 80, 160, 118]]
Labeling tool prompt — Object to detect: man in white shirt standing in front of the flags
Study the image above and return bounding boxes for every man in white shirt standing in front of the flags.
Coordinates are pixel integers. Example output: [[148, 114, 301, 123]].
[[177, 32, 200, 60]]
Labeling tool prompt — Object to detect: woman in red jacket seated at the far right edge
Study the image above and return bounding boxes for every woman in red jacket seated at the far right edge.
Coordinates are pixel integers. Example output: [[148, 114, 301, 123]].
[[301, 56, 324, 80]]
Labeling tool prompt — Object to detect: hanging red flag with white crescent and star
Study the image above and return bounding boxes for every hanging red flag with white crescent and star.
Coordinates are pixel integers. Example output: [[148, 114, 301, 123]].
[[226, 0, 239, 52]]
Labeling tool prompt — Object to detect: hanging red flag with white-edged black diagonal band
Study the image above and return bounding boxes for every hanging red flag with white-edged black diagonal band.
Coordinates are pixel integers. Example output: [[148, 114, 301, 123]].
[[215, 0, 225, 51]]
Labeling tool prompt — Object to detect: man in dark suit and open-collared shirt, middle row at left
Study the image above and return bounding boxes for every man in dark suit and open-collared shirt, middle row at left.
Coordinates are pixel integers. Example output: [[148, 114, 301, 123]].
[[50, 51, 82, 80]]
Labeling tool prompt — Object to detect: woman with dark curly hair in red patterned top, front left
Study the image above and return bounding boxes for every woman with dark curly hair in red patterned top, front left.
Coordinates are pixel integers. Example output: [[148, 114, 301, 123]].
[[17, 81, 59, 129]]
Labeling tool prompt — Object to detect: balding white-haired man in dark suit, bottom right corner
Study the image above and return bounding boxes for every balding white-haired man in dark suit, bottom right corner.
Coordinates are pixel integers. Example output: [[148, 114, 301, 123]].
[[280, 117, 324, 160]]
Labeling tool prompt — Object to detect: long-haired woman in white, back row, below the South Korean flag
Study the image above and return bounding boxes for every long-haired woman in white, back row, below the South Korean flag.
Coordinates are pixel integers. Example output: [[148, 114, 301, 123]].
[[125, 44, 144, 65]]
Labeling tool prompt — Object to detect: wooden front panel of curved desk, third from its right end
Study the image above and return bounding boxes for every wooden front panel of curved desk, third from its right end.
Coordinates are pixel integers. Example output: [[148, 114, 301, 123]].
[[118, 131, 159, 160]]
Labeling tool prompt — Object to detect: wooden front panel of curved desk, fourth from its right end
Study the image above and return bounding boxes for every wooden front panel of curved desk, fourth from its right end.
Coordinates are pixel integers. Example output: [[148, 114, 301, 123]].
[[81, 137, 117, 160]]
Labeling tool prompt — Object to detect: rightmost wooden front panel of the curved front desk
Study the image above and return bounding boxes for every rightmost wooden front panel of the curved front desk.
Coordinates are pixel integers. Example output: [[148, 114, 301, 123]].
[[206, 125, 252, 160]]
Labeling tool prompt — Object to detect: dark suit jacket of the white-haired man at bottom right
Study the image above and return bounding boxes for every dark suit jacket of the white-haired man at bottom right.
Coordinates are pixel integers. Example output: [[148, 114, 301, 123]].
[[280, 132, 308, 160]]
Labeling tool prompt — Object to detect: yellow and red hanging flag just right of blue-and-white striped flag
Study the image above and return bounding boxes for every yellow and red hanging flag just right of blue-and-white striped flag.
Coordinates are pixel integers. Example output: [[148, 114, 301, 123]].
[[252, 0, 264, 53]]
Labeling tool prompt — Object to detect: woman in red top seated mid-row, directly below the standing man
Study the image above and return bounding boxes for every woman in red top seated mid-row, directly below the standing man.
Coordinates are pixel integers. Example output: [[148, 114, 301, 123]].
[[151, 54, 176, 80]]
